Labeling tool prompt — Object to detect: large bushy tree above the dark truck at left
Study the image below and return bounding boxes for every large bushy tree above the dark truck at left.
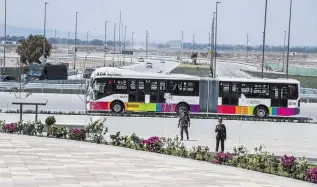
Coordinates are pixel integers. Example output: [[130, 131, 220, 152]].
[[16, 34, 52, 64]]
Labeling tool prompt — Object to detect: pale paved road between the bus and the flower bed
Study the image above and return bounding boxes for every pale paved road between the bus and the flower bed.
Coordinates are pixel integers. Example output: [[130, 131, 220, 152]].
[[0, 114, 317, 158]]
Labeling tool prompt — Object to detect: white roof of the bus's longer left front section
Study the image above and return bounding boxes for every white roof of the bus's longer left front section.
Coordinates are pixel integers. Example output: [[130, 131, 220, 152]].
[[91, 67, 200, 80]]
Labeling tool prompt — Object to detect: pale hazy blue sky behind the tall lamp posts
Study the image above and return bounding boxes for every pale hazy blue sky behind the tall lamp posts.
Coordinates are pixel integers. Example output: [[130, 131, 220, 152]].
[[0, 0, 317, 46]]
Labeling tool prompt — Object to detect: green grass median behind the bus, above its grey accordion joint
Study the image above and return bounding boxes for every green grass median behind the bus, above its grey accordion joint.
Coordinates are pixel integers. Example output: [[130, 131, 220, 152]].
[[171, 64, 210, 77]]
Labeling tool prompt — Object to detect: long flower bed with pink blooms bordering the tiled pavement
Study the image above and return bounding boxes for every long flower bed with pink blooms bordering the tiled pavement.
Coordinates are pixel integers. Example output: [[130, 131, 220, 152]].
[[0, 116, 317, 183]]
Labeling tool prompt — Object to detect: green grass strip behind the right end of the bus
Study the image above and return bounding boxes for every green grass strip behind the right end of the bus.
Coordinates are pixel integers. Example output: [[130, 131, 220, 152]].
[[242, 70, 317, 88]]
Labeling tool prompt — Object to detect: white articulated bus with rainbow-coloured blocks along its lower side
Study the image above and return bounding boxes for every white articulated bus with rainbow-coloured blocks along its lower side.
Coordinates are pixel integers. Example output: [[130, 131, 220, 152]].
[[87, 67, 300, 118]]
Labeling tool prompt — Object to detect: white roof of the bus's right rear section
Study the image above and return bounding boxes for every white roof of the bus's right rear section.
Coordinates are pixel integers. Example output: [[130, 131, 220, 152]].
[[219, 77, 299, 84]]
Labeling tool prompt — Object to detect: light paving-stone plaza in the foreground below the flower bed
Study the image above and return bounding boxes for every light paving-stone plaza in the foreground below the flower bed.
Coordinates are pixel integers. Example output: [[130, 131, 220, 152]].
[[0, 134, 312, 187]]
